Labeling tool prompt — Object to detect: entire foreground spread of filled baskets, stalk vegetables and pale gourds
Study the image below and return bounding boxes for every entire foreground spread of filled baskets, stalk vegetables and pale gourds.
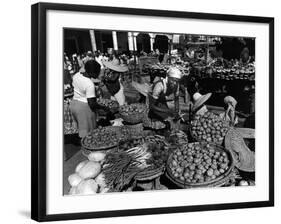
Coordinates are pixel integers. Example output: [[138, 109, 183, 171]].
[[64, 96, 255, 195]]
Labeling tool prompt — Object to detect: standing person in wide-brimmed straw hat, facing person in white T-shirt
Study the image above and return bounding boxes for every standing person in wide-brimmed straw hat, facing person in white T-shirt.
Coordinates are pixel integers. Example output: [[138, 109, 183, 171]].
[[103, 60, 128, 106]]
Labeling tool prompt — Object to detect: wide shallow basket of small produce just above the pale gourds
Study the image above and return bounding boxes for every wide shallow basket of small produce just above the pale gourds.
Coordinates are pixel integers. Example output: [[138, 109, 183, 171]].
[[81, 127, 119, 150]]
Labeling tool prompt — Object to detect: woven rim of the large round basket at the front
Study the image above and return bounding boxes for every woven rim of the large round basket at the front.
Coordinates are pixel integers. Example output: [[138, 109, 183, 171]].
[[166, 142, 234, 187]]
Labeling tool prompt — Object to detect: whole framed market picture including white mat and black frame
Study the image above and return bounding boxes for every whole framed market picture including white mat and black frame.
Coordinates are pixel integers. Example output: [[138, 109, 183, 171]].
[[31, 3, 274, 221]]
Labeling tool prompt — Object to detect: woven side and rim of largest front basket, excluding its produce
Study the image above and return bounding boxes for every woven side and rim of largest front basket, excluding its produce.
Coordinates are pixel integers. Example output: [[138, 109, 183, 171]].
[[166, 142, 234, 188]]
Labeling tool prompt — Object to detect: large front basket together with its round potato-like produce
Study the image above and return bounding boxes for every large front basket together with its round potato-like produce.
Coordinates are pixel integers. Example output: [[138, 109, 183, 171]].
[[166, 142, 234, 188]]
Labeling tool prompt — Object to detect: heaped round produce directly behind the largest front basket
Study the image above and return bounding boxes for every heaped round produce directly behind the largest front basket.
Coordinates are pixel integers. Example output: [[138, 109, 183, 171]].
[[190, 112, 229, 144]]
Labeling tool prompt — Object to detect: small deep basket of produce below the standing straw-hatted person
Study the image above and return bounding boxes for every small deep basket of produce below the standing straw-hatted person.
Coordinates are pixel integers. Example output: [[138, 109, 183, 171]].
[[119, 103, 147, 124]]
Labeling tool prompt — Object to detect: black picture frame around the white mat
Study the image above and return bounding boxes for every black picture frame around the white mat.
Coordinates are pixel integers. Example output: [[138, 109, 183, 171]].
[[31, 3, 274, 221]]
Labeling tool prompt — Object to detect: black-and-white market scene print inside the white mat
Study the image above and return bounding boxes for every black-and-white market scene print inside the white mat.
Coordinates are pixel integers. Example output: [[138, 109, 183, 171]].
[[64, 27, 256, 196]]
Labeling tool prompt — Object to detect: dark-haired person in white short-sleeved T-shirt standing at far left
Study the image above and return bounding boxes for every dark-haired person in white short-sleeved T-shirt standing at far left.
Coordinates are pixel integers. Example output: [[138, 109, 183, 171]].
[[70, 60, 107, 138]]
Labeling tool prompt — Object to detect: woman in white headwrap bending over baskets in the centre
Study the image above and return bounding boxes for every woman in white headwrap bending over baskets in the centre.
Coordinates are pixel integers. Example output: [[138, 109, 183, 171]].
[[148, 67, 182, 121]]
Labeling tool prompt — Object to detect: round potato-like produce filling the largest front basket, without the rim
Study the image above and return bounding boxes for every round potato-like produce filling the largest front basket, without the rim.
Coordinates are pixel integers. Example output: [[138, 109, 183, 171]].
[[168, 142, 231, 184]]
